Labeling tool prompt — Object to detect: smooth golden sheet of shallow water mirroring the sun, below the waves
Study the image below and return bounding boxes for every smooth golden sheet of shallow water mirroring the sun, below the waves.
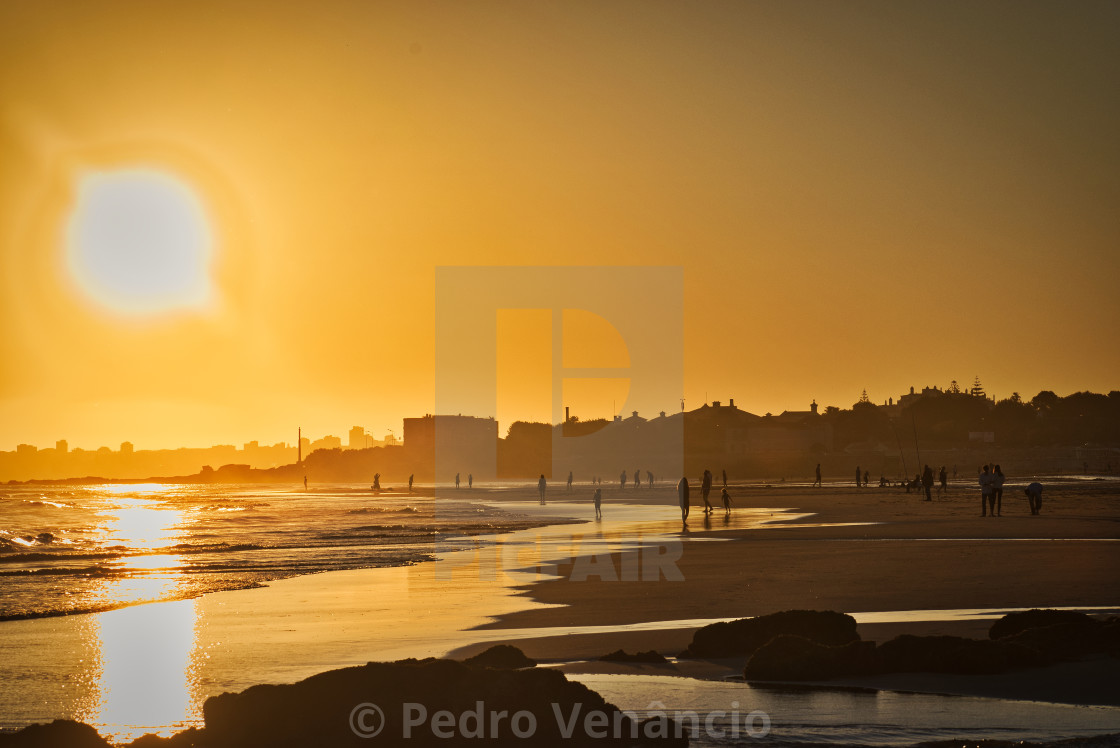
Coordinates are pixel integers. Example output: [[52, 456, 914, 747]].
[[0, 490, 837, 741]]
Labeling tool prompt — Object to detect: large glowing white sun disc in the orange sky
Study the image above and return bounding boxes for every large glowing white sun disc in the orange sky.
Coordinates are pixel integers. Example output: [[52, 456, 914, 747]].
[[66, 169, 214, 315]]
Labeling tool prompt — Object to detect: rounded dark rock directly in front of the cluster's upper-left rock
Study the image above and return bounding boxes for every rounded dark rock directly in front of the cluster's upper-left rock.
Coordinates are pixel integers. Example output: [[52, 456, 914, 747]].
[[743, 636, 877, 681]]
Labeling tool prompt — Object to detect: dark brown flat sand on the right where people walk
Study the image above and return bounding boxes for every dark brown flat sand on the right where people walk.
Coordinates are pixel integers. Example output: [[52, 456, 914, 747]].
[[486, 485, 1120, 638]]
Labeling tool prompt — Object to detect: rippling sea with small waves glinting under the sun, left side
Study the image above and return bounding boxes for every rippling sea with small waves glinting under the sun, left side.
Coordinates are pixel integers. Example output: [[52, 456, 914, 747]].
[[0, 484, 564, 620]]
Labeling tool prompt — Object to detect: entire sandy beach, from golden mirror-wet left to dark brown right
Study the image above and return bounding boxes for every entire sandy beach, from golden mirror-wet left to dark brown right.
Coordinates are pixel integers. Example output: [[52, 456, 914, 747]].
[[0, 481, 1120, 742]]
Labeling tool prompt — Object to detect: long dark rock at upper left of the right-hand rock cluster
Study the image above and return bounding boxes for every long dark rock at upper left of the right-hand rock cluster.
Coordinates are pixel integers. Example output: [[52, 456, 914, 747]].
[[681, 610, 859, 657]]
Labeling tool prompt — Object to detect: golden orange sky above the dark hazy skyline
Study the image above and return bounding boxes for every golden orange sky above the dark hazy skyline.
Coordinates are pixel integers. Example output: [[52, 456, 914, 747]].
[[0, 0, 1120, 449]]
